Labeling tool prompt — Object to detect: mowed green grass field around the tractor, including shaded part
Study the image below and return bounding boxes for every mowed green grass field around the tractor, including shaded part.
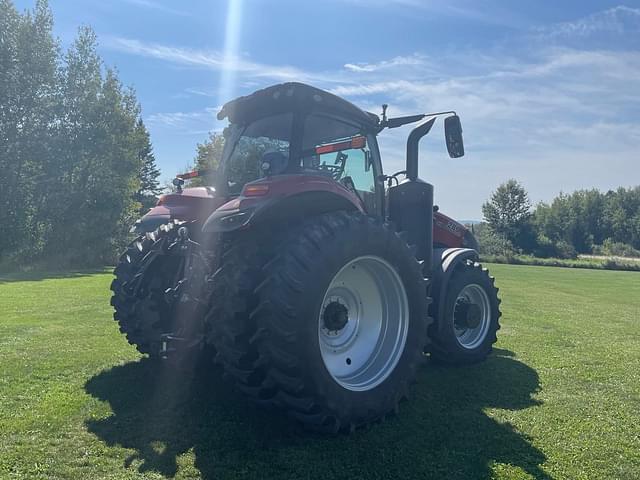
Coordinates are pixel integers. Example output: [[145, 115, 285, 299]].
[[0, 265, 640, 480]]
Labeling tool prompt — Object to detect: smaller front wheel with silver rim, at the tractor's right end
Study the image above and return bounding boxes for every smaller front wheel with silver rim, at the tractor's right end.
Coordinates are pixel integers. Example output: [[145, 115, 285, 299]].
[[429, 260, 502, 365]]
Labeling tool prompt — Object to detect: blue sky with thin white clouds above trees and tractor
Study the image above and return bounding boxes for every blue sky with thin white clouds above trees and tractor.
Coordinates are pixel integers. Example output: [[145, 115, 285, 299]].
[[16, 0, 640, 219]]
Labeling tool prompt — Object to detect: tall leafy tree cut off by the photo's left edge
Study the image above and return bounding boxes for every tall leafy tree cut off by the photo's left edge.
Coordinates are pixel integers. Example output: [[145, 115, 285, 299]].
[[0, 0, 58, 260]]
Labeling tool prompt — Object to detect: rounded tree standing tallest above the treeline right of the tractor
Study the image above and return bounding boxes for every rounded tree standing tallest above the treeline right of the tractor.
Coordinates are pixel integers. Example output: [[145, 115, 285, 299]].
[[482, 179, 532, 249]]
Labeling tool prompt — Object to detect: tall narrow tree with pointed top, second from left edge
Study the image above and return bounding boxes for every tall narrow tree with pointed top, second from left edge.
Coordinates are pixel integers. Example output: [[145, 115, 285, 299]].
[[43, 27, 111, 258]]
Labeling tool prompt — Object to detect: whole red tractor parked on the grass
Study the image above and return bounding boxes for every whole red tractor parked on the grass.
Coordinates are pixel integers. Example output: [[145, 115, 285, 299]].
[[111, 83, 500, 432]]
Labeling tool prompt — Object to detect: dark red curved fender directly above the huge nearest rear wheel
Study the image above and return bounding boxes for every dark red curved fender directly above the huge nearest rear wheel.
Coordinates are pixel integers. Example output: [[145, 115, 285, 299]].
[[203, 190, 362, 233]]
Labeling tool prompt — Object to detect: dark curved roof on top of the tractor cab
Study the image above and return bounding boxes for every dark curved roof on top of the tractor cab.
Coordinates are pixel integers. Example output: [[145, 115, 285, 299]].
[[218, 82, 380, 130]]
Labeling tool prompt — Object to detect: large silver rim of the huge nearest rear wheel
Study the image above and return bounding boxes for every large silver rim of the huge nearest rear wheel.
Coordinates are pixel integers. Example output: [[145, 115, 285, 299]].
[[318, 256, 409, 391]]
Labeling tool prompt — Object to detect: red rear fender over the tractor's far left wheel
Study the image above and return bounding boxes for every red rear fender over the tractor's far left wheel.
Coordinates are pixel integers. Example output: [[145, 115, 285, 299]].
[[131, 187, 225, 234]]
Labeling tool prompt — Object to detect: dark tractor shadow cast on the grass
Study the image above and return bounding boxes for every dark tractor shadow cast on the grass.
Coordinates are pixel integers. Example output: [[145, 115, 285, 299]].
[[86, 350, 550, 479]]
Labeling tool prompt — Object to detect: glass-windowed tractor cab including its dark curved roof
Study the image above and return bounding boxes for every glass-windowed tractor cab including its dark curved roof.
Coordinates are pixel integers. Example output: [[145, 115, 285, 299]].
[[216, 83, 383, 215]]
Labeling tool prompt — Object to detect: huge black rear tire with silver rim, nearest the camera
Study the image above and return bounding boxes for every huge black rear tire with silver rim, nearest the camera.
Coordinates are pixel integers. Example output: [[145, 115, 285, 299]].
[[211, 212, 429, 432]]
